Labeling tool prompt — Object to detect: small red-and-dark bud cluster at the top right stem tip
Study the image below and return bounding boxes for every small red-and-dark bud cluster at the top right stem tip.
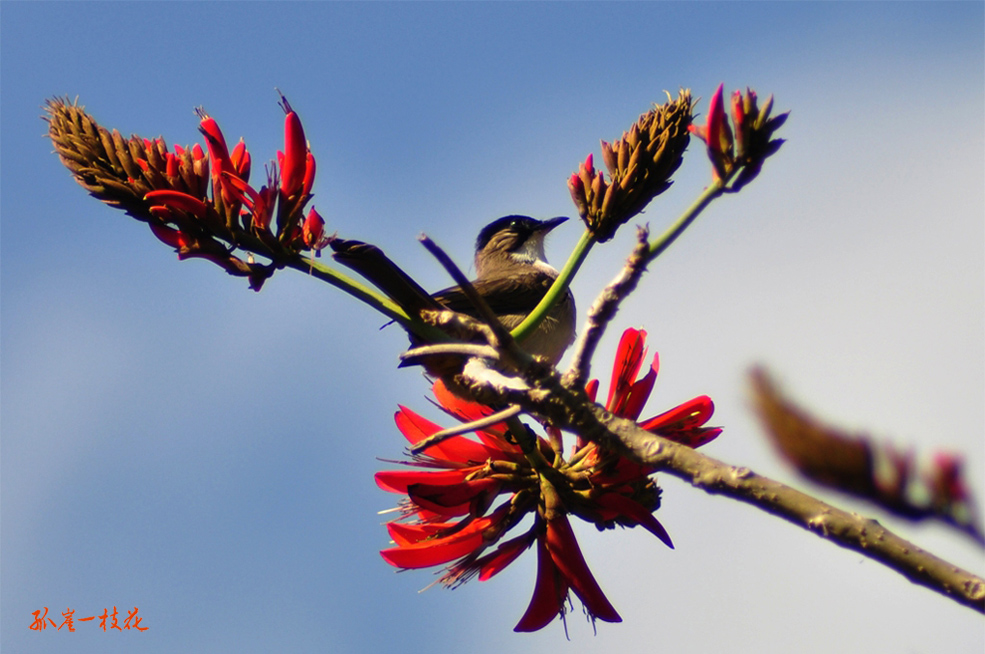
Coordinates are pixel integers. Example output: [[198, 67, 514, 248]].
[[688, 84, 789, 191]]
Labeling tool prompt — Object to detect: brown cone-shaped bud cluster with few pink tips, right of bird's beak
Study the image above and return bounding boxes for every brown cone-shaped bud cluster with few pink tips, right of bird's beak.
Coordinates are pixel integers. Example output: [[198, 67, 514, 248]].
[[568, 90, 693, 242]]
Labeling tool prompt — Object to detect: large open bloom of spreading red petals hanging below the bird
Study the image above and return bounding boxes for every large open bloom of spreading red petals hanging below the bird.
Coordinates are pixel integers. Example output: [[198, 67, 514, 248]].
[[376, 329, 721, 631]]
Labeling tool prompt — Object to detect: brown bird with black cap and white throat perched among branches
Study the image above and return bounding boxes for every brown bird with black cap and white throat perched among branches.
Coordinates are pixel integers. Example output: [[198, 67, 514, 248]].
[[331, 215, 575, 365]]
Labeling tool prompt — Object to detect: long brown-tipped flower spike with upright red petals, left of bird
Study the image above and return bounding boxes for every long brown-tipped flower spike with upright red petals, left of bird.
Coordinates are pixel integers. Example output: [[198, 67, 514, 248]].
[[47, 97, 328, 290]]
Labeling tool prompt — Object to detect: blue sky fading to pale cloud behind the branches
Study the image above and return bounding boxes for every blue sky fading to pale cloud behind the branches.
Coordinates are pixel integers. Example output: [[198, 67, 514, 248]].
[[0, 2, 985, 653]]
